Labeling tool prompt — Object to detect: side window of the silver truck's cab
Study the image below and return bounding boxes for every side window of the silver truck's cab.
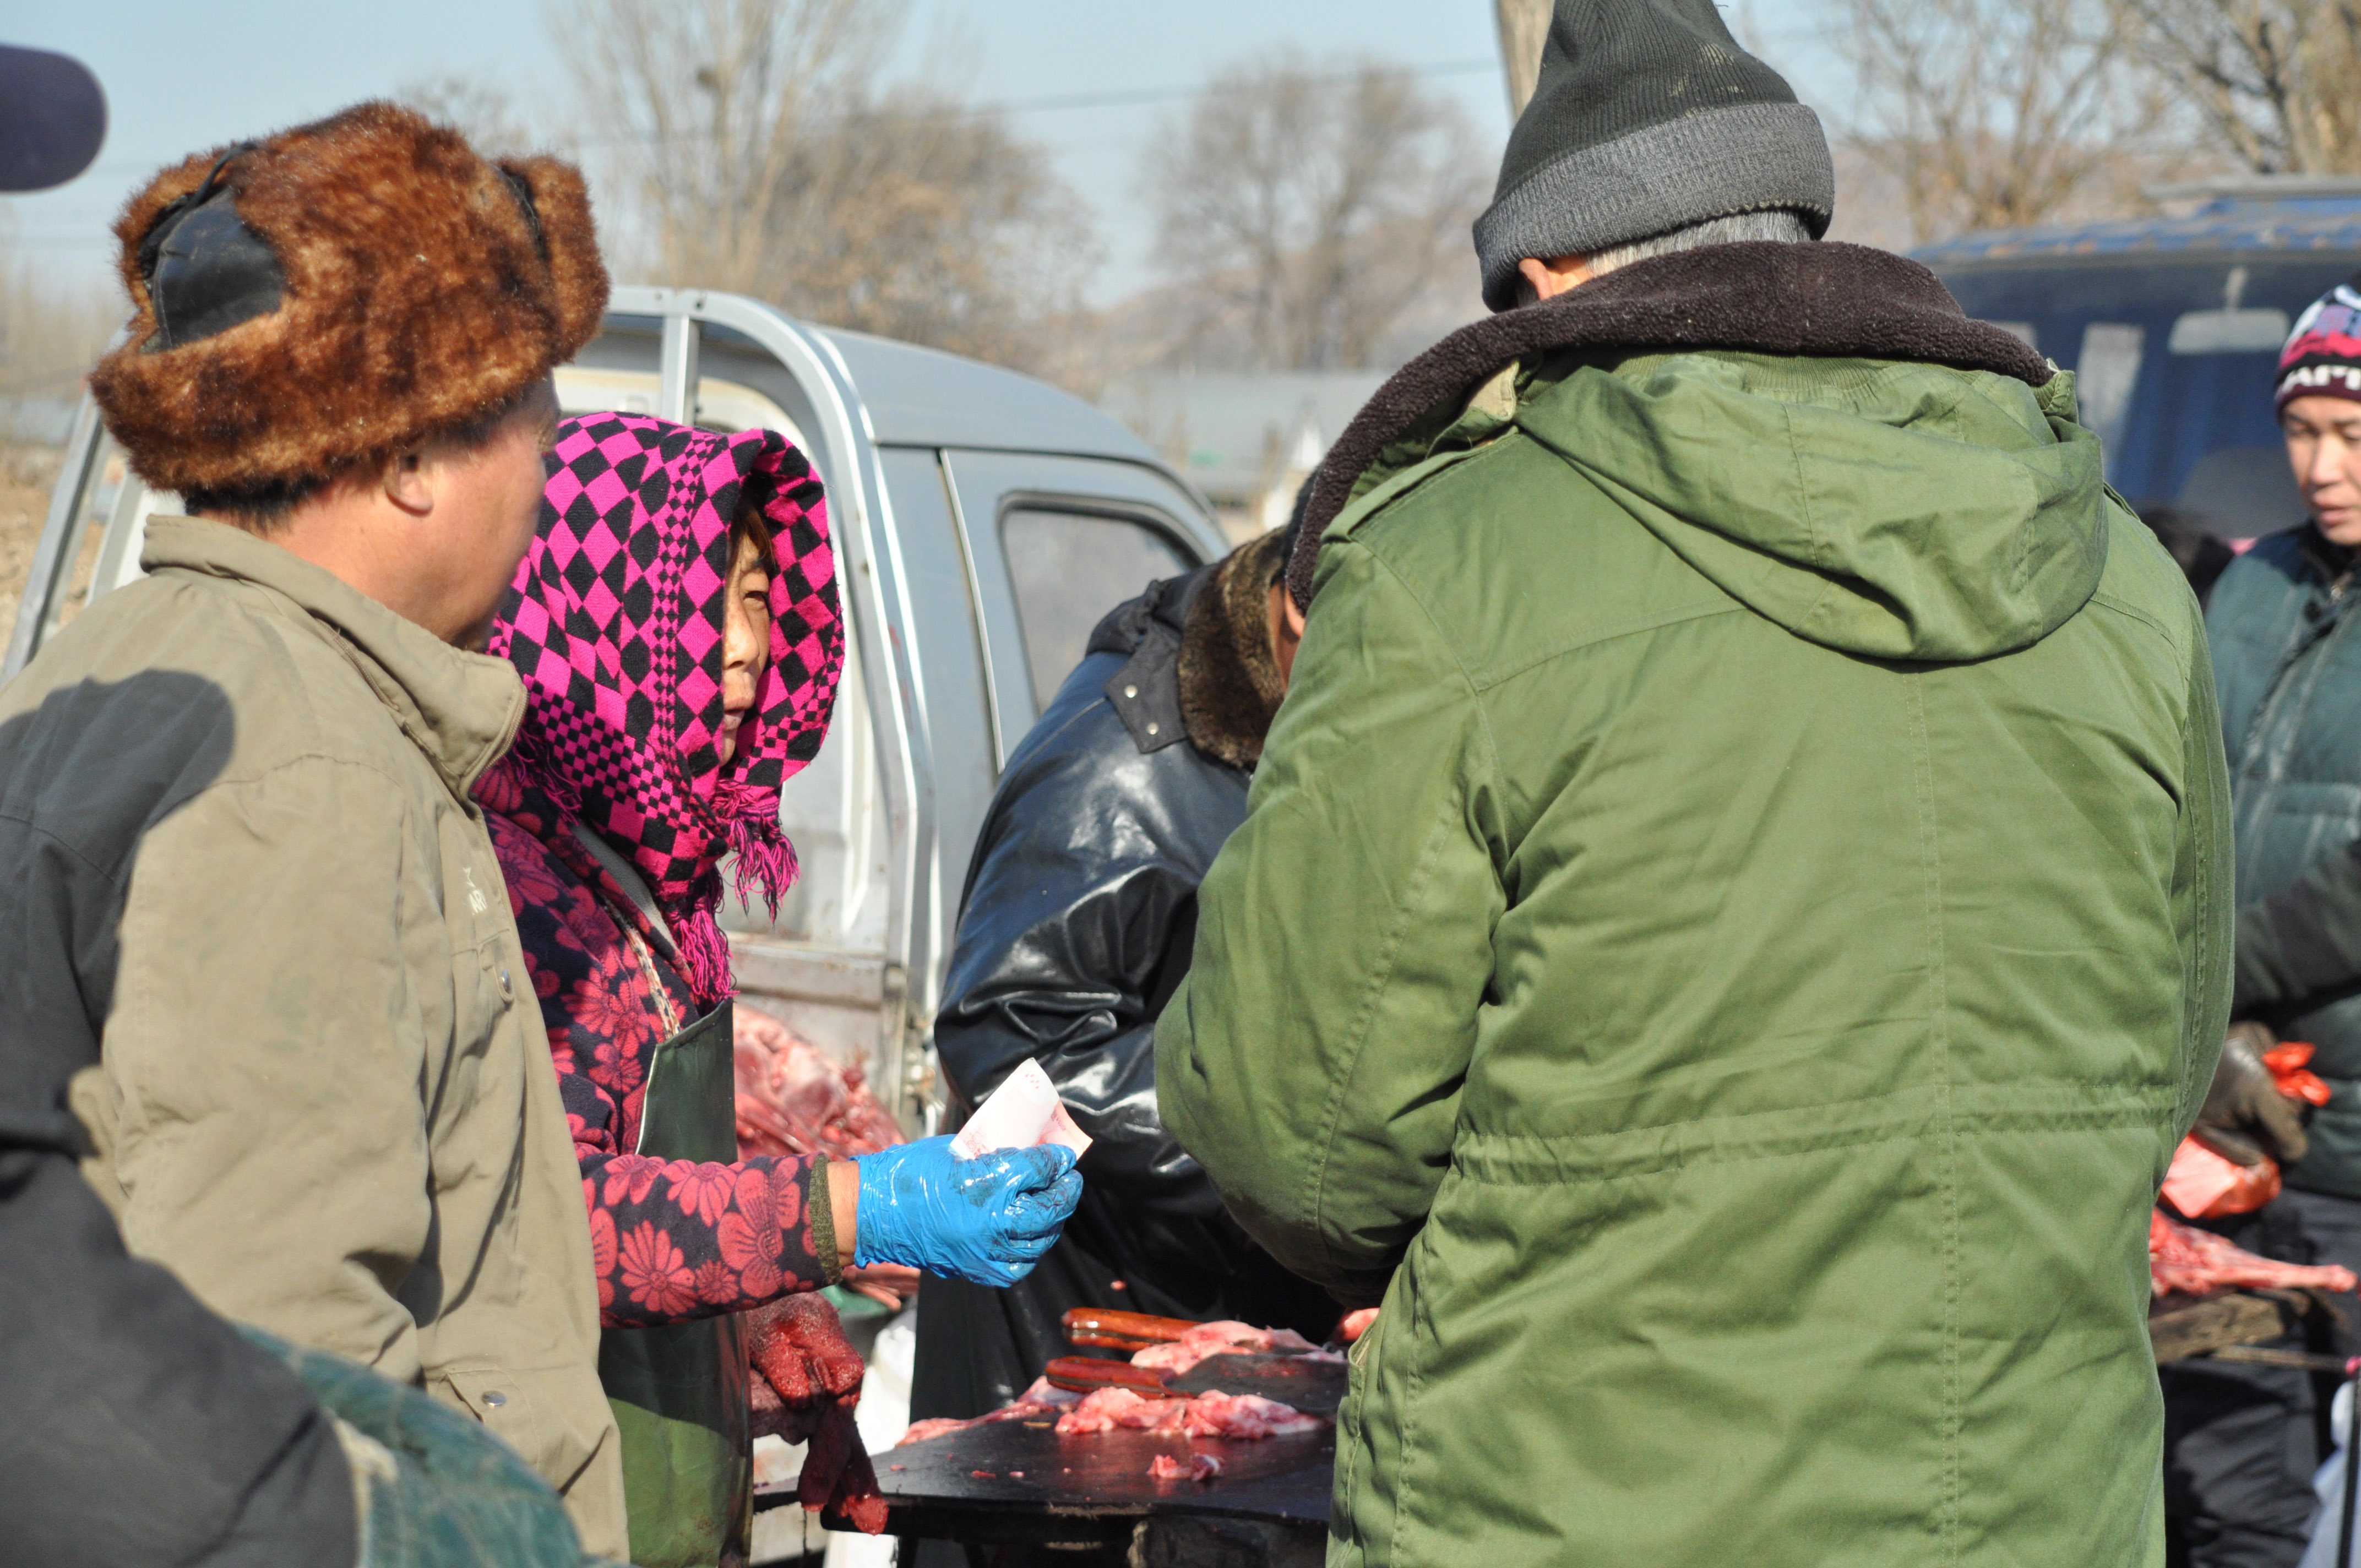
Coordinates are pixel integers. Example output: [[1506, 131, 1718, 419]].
[[1001, 508, 1188, 713]]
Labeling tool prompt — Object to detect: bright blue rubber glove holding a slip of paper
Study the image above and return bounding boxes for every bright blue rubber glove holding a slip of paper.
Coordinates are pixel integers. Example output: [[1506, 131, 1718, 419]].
[[852, 1138, 1081, 1284]]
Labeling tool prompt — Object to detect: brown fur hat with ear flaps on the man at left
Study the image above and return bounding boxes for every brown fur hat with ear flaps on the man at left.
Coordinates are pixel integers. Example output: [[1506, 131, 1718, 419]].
[[90, 104, 607, 491]]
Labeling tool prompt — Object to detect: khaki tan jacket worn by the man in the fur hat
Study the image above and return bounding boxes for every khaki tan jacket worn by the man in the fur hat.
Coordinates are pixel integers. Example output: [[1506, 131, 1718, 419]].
[[0, 517, 625, 1556]]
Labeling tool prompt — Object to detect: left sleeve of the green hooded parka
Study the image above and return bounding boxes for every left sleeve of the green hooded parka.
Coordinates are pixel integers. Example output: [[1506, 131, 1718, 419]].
[[1157, 538, 1506, 1304]]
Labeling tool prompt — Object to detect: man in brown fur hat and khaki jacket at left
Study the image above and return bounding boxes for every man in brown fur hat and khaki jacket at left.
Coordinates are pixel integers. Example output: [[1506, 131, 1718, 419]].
[[0, 104, 625, 1556]]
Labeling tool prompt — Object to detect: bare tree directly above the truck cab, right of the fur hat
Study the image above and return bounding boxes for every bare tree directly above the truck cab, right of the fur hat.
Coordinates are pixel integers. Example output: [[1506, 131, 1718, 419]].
[[552, 0, 1098, 383]]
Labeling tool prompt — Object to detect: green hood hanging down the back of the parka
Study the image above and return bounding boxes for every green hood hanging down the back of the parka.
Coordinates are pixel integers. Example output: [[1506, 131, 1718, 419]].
[[1516, 352, 2108, 661]]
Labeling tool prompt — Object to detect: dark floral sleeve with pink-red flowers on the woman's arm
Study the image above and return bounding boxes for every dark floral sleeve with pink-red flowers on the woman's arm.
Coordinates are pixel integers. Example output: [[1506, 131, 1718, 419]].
[[486, 812, 834, 1327]]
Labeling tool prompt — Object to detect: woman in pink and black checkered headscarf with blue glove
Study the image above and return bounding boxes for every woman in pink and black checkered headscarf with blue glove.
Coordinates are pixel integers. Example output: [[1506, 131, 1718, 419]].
[[477, 413, 1081, 1568]]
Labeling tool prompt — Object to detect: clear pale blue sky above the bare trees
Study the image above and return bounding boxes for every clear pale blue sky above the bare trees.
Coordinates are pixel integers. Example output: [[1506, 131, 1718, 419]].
[[0, 0, 1842, 297]]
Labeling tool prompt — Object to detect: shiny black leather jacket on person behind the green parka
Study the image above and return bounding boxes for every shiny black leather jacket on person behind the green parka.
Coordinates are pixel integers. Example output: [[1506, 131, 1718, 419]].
[[911, 567, 1339, 1417]]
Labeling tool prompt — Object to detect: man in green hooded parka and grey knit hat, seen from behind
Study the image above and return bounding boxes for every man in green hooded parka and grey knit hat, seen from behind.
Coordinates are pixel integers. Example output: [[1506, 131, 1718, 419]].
[[1157, 0, 2229, 1568]]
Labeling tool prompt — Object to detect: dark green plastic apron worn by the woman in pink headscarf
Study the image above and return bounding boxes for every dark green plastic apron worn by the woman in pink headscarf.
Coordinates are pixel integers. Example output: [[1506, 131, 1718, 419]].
[[580, 846, 753, 1568]]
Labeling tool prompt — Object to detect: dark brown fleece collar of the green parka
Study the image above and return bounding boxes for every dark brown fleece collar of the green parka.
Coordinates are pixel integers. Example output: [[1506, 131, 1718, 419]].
[[1287, 241, 2057, 609]]
